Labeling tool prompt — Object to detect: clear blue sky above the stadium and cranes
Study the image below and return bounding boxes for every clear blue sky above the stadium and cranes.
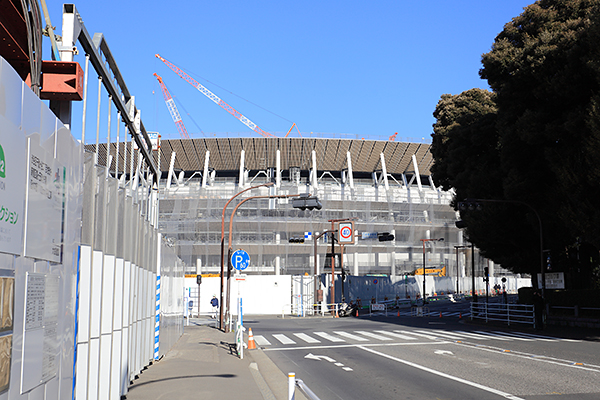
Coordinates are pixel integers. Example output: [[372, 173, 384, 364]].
[[44, 0, 533, 143]]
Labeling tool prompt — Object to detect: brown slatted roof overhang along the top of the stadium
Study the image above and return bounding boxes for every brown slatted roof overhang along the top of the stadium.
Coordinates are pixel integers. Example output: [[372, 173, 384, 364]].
[[92, 137, 433, 175]]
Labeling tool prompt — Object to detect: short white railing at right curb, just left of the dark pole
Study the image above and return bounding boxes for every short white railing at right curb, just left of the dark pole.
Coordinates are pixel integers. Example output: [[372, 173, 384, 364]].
[[471, 302, 535, 326]]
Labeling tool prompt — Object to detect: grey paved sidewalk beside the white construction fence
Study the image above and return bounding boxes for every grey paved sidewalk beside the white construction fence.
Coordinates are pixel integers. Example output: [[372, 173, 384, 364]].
[[125, 318, 306, 400]]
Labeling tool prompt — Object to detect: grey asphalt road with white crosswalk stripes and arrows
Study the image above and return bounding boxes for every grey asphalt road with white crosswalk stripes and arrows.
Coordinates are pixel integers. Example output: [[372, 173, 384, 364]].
[[244, 313, 600, 400]]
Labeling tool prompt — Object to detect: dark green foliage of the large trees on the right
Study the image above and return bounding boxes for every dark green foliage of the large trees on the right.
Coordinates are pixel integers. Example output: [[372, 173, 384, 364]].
[[432, 0, 600, 282]]
